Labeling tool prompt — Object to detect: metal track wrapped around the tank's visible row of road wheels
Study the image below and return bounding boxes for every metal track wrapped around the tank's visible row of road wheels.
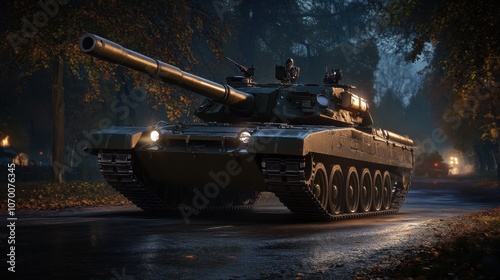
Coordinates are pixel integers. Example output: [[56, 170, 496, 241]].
[[262, 156, 411, 220]]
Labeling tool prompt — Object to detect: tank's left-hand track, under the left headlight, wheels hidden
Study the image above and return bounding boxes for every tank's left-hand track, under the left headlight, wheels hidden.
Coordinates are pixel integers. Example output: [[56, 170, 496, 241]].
[[97, 151, 260, 212]]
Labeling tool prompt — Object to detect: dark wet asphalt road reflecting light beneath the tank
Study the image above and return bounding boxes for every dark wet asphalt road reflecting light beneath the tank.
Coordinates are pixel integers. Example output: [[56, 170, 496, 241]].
[[0, 178, 500, 280]]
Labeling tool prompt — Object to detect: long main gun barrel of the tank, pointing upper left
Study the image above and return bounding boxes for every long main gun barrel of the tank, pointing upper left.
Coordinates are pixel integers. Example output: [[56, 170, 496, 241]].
[[79, 34, 254, 111]]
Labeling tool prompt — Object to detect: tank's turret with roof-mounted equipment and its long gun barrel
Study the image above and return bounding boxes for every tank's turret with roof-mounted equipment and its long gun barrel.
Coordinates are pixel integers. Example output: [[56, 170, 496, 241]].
[[80, 34, 373, 126]]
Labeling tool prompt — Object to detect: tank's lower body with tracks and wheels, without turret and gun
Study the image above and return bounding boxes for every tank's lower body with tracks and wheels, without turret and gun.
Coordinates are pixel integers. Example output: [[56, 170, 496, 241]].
[[89, 124, 414, 220]]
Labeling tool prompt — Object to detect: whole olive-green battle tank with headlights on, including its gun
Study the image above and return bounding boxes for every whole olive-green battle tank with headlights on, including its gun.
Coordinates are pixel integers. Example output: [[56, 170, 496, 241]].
[[79, 34, 414, 222]]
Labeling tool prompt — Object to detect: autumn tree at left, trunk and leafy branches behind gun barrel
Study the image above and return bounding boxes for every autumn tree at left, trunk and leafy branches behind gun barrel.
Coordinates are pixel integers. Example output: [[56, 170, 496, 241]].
[[0, 0, 225, 182]]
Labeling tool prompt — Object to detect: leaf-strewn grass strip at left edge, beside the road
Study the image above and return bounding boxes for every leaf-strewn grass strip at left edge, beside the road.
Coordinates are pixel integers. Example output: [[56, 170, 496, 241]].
[[0, 182, 131, 210]]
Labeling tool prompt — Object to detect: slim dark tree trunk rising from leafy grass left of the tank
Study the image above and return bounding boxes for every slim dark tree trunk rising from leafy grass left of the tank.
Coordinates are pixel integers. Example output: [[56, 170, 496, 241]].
[[52, 55, 65, 183]]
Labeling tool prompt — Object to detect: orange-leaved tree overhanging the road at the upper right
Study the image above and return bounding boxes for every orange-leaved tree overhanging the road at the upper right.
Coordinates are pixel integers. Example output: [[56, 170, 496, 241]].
[[384, 0, 500, 179]]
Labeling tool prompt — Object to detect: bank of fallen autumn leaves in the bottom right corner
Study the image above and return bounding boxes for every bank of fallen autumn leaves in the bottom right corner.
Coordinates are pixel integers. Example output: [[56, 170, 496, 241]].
[[363, 208, 500, 280]]
